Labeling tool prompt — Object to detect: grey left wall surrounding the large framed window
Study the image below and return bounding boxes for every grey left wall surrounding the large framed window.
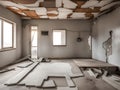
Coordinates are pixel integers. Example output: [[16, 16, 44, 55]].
[[0, 6, 22, 67]]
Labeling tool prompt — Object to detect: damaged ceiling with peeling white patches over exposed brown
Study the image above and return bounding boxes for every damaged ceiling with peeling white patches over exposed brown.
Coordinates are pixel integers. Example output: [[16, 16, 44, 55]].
[[0, 0, 120, 19]]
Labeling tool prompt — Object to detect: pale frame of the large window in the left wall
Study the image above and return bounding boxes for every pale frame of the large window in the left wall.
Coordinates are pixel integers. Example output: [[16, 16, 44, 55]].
[[0, 17, 16, 52]]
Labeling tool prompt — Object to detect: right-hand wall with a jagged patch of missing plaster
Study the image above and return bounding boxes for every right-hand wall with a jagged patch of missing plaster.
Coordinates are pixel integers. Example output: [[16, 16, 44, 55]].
[[92, 8, 120, 66]]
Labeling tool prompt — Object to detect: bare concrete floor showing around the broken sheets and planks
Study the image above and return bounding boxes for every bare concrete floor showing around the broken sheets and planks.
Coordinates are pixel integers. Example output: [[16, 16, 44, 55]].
[[0, 60, 116, 90]]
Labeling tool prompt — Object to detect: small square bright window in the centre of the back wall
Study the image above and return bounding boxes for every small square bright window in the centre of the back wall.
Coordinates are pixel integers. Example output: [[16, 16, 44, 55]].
[[53, 30, 66, 45]]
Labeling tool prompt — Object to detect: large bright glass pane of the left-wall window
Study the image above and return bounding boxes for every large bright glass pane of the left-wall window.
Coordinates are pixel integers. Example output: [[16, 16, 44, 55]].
[[3, 21, 13, 48]]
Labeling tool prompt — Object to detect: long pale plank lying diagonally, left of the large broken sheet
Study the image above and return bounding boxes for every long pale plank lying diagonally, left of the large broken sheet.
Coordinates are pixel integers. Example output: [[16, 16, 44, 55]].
[[5, 62, 39, 85]]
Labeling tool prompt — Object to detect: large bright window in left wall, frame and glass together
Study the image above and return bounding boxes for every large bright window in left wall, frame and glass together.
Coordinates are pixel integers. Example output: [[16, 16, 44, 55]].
[[0, 18, 16, 51]]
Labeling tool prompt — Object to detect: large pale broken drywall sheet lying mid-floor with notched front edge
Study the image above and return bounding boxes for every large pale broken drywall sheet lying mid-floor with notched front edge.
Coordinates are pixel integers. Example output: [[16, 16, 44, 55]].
[[7, 63, 83, 87]]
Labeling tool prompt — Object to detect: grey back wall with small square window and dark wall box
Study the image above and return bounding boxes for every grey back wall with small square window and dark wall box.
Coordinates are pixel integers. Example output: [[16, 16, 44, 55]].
[[23, 20, 91, 58]]
